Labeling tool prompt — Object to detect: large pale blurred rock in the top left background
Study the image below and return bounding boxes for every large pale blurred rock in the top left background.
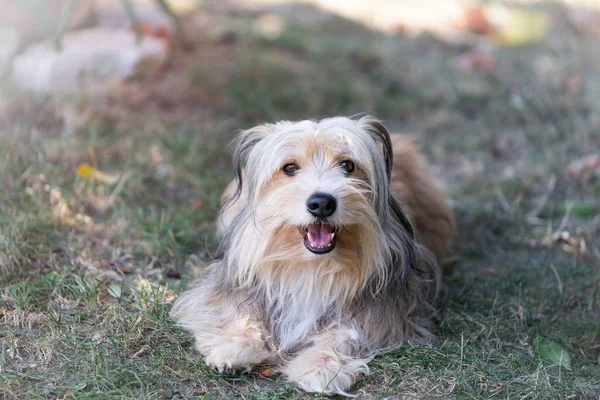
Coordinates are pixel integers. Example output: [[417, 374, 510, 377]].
[[11, 28, 169, 93]]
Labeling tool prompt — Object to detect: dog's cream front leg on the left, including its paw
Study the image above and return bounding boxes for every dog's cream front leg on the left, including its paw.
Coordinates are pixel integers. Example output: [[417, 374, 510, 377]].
[[172, 287, 272, 373]]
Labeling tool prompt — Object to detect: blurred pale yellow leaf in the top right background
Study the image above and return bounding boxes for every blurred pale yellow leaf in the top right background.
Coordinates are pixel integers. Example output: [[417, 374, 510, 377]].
[[490, 9, 549, 47]]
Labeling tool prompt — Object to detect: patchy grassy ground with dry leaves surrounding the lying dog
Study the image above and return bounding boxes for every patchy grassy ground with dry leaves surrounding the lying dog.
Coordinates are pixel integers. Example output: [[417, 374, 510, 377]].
[[0, 3, 600, 399]]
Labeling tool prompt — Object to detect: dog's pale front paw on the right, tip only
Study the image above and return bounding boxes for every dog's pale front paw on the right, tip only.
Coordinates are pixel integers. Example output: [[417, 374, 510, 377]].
[[283, 350, 369, 396]]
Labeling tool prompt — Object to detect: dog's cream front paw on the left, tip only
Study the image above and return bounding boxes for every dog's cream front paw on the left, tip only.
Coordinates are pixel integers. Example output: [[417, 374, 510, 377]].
[[204, 340, 269, 373]]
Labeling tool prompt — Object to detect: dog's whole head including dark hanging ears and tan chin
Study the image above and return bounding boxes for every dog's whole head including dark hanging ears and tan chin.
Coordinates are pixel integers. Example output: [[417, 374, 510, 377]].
[[227, 118, 391, 259]]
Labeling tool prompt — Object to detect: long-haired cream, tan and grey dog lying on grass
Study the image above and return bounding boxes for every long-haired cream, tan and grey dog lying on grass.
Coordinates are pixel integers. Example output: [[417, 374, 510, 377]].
[[172, 117, 455, 395]]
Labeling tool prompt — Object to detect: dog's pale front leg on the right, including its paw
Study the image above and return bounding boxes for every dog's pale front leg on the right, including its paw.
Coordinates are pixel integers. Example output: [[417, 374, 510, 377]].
[[282, 327, 370, 396]]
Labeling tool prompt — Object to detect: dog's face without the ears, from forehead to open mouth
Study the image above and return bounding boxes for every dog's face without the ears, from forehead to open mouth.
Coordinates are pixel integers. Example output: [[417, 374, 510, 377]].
[[257, 129, 371, 255]]
